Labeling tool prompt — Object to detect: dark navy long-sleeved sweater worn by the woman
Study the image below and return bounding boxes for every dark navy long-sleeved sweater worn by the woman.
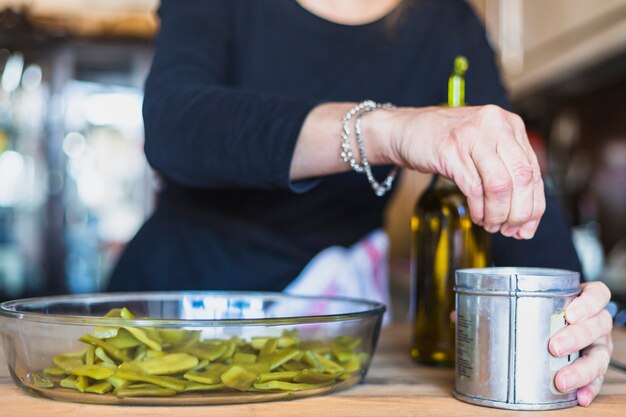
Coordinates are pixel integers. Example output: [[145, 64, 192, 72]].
[[109, 0, 579, 290]]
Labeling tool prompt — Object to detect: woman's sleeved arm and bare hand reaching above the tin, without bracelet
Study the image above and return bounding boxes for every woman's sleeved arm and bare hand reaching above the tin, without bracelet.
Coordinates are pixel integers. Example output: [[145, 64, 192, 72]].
[[144, 0, 544, 238]]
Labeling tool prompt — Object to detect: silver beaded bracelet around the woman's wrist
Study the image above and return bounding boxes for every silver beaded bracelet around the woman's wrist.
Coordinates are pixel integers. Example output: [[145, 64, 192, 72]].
[[341, 100, 398, 197]]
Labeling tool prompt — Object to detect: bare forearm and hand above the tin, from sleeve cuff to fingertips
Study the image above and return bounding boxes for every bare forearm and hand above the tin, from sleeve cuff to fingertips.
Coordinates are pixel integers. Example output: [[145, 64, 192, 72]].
[[290, 103, 546, 239]]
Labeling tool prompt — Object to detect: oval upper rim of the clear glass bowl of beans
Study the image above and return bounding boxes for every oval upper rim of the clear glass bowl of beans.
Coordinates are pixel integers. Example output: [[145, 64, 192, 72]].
[[0, 291, 387, 328]]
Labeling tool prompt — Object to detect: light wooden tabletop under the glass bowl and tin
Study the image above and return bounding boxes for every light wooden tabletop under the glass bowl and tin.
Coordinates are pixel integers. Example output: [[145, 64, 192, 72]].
[[0, 325, 626, 417]]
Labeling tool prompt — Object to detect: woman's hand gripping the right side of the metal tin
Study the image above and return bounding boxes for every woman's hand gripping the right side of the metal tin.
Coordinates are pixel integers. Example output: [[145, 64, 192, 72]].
[[549, 282, 613, 407]]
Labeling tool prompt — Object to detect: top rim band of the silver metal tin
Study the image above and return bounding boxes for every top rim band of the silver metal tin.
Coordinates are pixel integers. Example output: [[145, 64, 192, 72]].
[[454, 267, 580, 297]]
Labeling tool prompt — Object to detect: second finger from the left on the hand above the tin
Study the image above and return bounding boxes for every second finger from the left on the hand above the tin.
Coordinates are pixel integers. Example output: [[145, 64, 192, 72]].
[[470, 143, 513, 233]]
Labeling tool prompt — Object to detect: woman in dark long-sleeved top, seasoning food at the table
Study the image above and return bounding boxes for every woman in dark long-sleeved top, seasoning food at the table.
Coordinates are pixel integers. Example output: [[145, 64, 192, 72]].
[[111, 0, 612, 405]]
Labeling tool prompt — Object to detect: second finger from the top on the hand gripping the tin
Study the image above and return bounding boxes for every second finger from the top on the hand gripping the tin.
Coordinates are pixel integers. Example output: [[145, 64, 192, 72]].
[[548, 310, 613, 357]]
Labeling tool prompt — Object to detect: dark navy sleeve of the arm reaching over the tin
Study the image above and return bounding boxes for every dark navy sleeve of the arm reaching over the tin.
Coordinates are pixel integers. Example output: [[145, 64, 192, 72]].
[[143, 0, 318, 190]]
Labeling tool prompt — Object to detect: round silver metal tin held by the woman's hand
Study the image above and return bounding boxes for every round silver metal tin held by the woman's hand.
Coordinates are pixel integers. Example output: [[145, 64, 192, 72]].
[[454, 268, 580, 410]]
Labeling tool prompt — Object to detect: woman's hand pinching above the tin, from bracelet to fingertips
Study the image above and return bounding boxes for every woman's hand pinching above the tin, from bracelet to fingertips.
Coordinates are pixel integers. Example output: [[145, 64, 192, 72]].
[[391, 105, 545, 239]]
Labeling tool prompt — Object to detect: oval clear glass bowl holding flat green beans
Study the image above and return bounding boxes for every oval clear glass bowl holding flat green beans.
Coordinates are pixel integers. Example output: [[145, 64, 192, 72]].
[[0, 292, 385, 405]]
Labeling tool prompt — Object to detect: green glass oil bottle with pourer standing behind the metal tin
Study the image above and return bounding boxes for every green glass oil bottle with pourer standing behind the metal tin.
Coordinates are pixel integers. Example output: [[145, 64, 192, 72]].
[[411, 56, 491, 366]]
